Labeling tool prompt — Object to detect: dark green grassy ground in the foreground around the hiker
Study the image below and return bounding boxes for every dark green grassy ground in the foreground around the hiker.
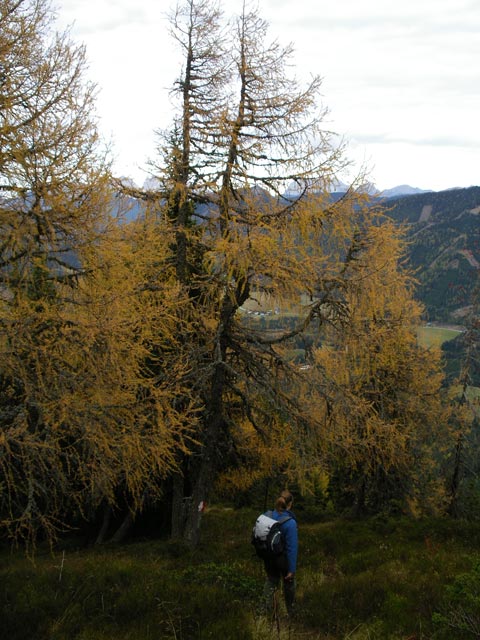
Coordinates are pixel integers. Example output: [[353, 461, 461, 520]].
[[0, 507, 480, 640]]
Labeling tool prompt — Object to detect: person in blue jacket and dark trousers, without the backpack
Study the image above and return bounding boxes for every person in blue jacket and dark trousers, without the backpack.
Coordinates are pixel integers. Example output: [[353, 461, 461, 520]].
[[263, 491, 298, 617]]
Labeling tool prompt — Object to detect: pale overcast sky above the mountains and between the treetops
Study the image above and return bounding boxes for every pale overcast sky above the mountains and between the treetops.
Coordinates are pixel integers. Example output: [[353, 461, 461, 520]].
[[55, 0, 480, 191]]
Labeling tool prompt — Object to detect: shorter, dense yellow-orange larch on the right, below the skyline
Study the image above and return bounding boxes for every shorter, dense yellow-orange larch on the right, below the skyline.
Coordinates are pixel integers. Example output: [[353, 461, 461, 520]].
[[298, 218, 451, 508]]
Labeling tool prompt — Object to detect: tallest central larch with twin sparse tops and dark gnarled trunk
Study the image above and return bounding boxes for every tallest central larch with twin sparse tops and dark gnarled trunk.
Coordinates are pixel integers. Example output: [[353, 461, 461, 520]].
[[144, 0, 376, 544]]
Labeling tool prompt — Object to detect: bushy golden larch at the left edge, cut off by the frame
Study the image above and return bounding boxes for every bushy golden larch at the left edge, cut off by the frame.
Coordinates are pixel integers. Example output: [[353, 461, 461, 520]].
[[0, 0, 195, 543]]
